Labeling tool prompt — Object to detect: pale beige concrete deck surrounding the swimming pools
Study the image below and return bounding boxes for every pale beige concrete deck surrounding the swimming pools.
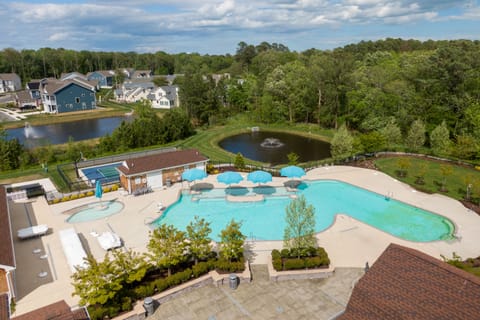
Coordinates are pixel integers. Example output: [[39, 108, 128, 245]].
[[10, 166, 480, 315]]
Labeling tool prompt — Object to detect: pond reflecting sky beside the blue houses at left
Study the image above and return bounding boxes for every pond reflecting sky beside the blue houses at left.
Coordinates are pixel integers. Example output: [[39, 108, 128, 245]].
[[5, 116, 132, 148]]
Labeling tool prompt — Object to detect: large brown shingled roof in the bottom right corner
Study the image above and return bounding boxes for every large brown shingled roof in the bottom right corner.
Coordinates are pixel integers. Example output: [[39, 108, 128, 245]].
[[337, 244, 480, 320]]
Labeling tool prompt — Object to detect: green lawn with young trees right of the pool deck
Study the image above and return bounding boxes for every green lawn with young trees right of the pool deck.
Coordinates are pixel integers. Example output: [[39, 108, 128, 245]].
[[375, 157, 480, 200]]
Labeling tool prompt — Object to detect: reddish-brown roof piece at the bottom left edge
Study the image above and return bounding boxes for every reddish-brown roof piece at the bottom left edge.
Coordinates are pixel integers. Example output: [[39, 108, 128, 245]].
[[12, 300, 90, 320]]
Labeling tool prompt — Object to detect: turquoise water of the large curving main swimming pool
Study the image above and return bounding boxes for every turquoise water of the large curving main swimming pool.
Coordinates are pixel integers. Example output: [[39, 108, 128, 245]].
[[152, 180, 454, 242]]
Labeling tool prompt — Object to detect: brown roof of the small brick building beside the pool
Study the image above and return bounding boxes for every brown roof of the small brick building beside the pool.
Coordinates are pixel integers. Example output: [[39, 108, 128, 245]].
[[117, 149, 208, 176]]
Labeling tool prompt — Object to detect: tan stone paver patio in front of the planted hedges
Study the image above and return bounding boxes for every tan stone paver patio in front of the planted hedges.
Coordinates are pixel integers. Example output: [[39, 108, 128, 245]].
[[149, 265, 364, 320]]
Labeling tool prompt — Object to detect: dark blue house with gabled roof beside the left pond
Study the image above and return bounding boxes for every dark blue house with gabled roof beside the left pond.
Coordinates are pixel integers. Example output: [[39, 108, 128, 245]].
[[40, 79, 96, 113]]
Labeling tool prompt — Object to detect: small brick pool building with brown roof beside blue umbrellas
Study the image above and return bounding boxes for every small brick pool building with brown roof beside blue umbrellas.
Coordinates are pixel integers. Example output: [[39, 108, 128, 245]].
[[117, 149, 208, 194]]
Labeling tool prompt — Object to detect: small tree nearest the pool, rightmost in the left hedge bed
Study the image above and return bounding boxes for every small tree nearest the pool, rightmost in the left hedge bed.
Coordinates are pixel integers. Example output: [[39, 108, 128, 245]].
[[220, 219, 247, 262]]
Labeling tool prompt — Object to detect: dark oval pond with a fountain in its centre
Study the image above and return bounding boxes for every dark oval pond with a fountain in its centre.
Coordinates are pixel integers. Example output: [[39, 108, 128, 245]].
[[219, 131, 330, 165]]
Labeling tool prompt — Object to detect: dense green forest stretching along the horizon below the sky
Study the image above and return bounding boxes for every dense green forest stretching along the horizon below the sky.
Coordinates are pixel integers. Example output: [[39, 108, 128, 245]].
[[0, 38, 480, 170]]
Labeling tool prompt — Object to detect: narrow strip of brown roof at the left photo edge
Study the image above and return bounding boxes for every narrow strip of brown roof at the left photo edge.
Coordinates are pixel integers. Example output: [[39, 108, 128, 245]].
[[0, 186, 15, 268]]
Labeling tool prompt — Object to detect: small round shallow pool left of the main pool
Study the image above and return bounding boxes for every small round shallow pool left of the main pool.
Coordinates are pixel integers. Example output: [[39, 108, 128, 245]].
[[66, 201, 123, 223]]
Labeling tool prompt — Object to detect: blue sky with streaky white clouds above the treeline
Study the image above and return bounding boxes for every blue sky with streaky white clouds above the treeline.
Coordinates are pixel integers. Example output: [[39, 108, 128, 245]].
[[0, 0, 480, 54]]
